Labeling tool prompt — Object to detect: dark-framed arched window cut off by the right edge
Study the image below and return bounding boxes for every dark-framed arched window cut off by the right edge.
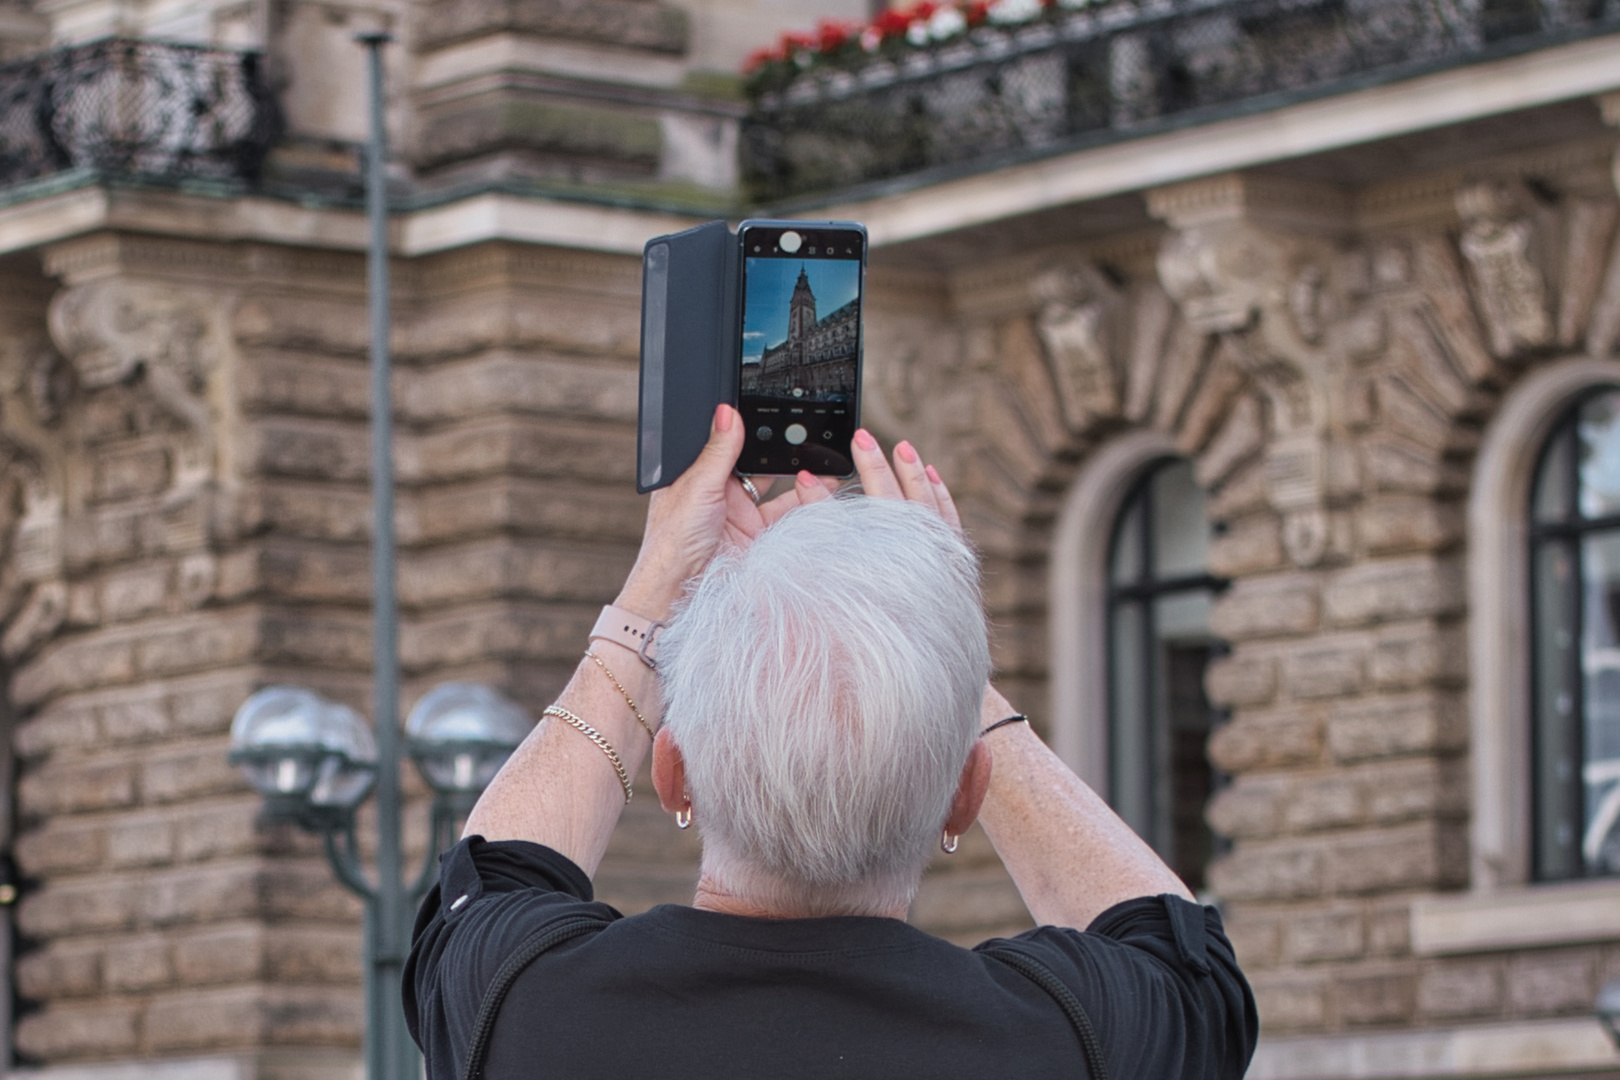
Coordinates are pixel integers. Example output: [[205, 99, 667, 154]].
[[1529, 387, 1620, 881]]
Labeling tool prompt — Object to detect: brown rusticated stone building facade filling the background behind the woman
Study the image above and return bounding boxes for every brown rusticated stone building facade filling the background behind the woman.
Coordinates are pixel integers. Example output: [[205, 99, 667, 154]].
[[0, 0, 1620, 1080]]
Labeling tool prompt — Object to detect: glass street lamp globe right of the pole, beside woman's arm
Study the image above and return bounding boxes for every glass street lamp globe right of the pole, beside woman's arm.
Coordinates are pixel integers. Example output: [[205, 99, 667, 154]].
[[405, 682, 535, 798]]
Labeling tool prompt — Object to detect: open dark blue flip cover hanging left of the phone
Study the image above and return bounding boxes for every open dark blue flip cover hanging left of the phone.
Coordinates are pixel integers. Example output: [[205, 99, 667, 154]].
[[635, 222, 742, 492]]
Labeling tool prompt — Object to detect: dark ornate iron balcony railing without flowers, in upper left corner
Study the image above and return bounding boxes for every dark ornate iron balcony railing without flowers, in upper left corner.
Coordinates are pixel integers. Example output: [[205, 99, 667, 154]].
[[0, 37, 280, 188]]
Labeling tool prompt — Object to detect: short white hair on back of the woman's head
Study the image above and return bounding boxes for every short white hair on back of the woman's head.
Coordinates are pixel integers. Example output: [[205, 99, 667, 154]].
[[658, 497, 990, 915]]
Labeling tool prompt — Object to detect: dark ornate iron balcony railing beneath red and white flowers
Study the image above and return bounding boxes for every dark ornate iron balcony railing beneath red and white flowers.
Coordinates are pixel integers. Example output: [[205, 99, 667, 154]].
[[744, 0, 1620, 202]]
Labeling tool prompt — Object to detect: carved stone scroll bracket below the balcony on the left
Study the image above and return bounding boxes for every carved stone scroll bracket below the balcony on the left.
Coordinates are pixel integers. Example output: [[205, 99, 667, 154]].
[[49, 280, 220, 489]]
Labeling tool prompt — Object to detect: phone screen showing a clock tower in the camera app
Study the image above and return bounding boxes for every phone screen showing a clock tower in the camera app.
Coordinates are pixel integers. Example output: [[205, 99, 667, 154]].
[[737, 222, 867, 476]]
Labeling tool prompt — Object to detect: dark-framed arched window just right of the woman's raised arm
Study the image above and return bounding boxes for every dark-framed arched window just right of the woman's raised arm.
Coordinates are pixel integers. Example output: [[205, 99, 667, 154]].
[[1105, 458, 1220, 891]]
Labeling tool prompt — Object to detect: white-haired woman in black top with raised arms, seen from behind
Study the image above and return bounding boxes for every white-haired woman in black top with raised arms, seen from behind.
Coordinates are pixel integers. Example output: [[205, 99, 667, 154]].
[[405, 406, 1256, 1080]]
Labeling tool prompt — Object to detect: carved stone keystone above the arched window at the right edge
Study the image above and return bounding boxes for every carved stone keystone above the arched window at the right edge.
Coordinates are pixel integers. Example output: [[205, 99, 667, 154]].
[[1456, 180, 1554, 358]]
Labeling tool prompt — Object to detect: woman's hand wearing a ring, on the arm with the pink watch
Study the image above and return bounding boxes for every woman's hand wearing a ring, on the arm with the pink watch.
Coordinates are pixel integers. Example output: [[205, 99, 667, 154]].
[[614, 405, 838, 620]]
